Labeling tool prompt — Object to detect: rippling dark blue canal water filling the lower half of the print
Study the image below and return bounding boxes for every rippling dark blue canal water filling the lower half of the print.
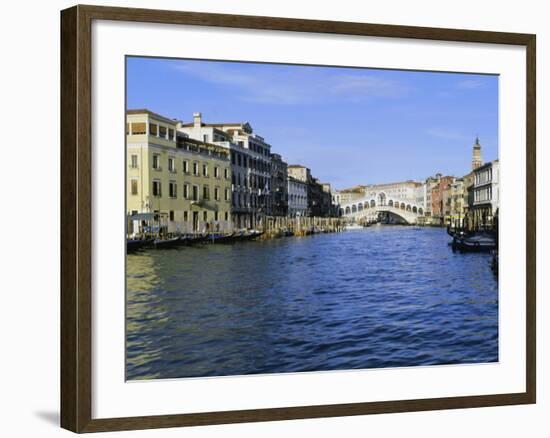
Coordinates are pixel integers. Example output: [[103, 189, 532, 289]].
[[126, 226, 498, 379]]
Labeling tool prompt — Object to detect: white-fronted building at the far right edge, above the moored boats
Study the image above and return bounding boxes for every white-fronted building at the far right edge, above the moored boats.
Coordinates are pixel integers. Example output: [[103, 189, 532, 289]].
[[469, 160, 500, 228]]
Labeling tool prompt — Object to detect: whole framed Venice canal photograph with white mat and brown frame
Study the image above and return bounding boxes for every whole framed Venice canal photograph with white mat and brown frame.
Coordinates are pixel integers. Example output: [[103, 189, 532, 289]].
[[61, 6, 536, 432]]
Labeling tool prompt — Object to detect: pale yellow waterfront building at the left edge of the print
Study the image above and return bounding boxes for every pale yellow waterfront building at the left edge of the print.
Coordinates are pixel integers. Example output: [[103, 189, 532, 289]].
[[126, 109, 232, 234]]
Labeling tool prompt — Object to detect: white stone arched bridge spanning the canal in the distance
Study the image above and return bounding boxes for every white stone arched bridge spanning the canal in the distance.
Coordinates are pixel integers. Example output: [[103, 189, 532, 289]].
[[340, 192, 424, 224]]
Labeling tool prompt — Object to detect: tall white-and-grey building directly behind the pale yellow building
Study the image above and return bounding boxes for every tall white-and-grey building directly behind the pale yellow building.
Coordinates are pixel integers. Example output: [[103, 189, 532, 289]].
[[179, 113, 273, 228]]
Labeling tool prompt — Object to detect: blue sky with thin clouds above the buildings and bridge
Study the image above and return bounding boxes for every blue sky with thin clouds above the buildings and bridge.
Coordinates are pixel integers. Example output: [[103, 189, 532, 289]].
[[127, 58, 498, 188]]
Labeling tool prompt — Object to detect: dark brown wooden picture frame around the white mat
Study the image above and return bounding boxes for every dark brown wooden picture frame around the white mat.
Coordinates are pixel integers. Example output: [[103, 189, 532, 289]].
[[61, 6, 536, 432]]
